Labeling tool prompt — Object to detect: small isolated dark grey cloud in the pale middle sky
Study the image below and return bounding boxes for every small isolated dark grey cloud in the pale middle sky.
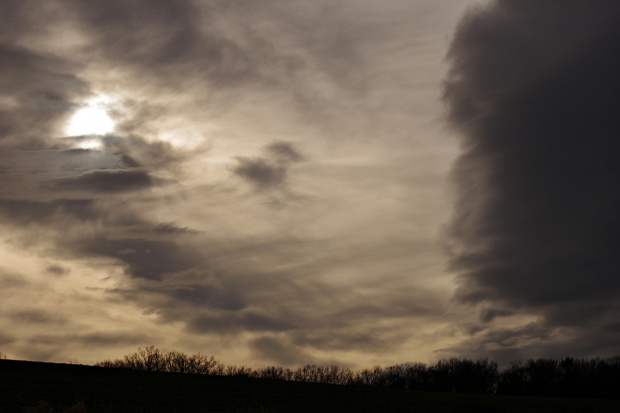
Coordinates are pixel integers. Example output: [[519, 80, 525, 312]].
[[233, 142, 303, 189]]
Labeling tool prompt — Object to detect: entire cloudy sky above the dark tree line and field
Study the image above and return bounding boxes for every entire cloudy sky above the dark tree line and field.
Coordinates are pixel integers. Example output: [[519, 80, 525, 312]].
[[0, 0, 620, 368]]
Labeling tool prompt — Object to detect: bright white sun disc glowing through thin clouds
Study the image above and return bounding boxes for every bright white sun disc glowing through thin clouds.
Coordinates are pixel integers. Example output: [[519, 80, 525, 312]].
[[65, 96, 115, 136]]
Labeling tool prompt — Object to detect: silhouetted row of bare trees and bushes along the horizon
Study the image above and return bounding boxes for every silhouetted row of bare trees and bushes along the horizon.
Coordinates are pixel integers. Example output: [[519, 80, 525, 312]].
[[89, 346, 620, 398]]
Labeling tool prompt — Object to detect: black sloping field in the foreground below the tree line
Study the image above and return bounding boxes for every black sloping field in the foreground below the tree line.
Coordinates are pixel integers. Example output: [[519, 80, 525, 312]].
[[0, 360, 620, 413]]
